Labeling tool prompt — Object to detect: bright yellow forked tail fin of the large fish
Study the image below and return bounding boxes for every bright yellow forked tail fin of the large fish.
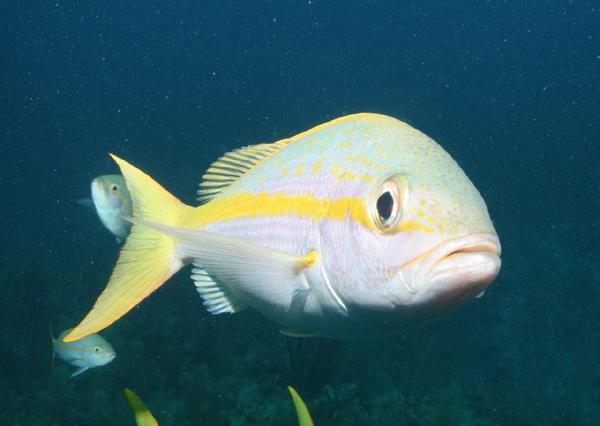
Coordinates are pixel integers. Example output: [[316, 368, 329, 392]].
[[63, 154, 192, 342]]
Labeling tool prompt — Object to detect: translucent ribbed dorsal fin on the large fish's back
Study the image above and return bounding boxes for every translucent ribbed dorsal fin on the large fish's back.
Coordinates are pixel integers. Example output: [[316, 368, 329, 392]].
[[198, 139, 292, 204]]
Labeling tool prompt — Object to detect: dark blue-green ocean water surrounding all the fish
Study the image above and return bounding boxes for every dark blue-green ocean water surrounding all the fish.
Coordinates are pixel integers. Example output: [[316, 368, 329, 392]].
[[0, 0, 600, 425]]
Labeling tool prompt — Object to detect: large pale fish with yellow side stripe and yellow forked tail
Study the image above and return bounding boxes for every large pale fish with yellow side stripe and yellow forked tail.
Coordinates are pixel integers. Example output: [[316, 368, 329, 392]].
[[65, 113, 500, 341]]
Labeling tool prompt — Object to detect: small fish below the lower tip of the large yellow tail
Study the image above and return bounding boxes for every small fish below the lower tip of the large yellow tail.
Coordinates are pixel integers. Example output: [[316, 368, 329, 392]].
[[50, 329, 117, 377]]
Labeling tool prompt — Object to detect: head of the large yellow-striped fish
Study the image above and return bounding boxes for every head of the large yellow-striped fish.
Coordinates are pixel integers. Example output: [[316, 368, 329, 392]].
[[322, 115, 501, 331]]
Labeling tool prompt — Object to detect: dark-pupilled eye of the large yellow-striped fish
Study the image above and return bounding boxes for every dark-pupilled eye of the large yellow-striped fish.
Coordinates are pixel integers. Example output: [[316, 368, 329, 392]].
[[371, 175, 408, 233]]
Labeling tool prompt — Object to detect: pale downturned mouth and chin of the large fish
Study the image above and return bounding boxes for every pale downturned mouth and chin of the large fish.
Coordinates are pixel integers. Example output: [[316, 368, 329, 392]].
[[400, 233, 502, 317]]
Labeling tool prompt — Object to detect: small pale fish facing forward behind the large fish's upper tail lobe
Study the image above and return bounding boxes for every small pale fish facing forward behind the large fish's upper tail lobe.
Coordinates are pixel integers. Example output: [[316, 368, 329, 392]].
[[92, 175, 131, 244]]
